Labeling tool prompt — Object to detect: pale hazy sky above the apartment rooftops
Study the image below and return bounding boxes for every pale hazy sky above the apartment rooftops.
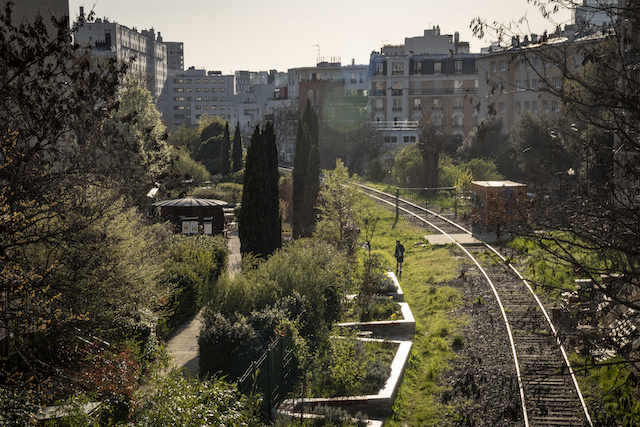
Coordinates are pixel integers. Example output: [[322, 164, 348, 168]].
[[69, 0, 571, 74]]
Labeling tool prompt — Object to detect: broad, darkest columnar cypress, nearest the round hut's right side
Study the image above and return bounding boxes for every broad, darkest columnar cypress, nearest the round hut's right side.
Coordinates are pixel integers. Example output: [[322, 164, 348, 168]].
[[237, 123, 281, 258]]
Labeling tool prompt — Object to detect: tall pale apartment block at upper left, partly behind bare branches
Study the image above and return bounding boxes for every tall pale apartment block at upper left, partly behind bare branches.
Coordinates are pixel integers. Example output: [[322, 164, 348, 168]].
[[75, 12, 168, 106]]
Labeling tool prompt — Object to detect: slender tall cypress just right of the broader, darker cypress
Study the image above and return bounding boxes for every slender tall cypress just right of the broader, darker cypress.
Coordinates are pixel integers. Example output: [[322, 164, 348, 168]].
[[292, 100, 320, 238]]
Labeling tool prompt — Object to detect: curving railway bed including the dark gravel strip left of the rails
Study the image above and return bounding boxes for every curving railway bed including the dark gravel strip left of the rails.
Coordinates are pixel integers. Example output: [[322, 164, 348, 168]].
[[364, 184, 591, 427]]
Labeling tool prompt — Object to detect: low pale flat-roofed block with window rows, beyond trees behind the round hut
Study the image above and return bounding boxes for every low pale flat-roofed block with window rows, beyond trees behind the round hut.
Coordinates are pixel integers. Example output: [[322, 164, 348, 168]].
[[161, 67, 236, 127]]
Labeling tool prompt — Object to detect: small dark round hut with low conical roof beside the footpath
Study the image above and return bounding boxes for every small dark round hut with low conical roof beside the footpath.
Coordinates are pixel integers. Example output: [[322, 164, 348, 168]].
[[153, 197, 229, 235]]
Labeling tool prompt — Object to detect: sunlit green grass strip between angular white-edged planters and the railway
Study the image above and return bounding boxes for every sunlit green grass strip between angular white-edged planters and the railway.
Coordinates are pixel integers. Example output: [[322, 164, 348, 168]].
[[358, 201, 465, 427]]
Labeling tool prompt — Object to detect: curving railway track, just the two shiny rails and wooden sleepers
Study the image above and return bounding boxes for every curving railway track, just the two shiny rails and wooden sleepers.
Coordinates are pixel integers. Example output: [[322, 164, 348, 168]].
[[359, 185, 593, 427]]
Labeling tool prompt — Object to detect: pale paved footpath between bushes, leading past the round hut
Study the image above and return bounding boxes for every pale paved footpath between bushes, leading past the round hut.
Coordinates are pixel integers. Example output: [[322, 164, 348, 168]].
[[167, 231, 242, 377]]
